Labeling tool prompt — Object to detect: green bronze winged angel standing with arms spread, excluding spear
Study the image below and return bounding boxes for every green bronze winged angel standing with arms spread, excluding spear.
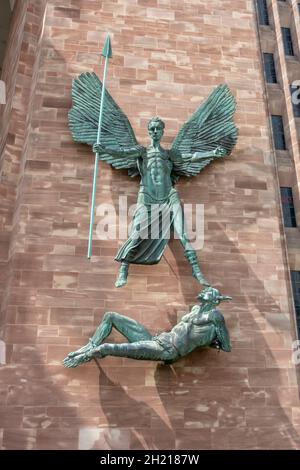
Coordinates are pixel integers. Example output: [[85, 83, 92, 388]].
[[69, 72, 238, 287]]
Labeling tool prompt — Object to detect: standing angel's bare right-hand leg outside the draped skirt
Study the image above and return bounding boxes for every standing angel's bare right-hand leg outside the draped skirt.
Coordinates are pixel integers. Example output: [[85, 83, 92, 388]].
[[173, 205, 210, 286]]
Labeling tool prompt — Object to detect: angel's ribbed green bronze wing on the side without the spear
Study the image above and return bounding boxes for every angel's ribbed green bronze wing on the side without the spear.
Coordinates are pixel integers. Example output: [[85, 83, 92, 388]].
[[171, 85, 238, 177]]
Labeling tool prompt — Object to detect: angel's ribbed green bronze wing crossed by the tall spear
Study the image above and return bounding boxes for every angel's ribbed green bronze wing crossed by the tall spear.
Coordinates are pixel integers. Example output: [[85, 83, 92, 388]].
[[69, 72, 140, 168]]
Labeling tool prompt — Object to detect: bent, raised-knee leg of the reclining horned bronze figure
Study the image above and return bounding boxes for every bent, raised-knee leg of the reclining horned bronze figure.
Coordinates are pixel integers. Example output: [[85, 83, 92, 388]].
[[64, 312, 152, 358]]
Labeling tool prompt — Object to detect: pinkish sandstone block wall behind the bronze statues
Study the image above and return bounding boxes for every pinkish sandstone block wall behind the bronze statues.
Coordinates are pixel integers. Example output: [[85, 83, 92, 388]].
[[0, 0, 300, 449]]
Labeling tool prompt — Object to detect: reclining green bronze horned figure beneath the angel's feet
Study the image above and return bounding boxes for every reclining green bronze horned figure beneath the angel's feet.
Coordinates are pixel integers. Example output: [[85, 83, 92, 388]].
[[64, 287, 231, 367]]
